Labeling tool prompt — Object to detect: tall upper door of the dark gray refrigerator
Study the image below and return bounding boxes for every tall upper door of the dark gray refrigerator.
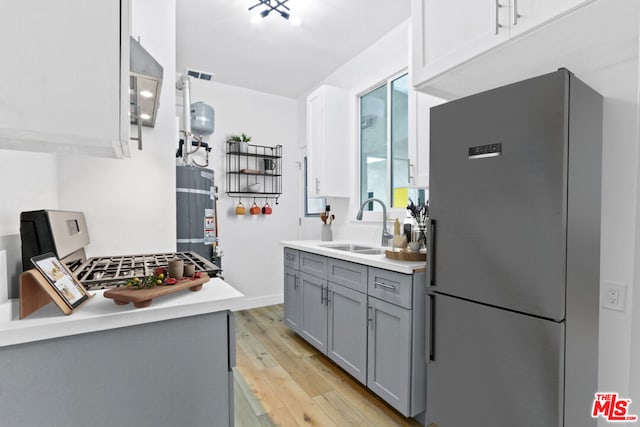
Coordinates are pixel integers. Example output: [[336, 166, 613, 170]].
[[429, 71, 568, 320]]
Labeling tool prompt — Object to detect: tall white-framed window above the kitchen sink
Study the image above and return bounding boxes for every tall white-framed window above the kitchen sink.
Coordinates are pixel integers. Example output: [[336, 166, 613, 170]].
[[360, 73, 424, 214]]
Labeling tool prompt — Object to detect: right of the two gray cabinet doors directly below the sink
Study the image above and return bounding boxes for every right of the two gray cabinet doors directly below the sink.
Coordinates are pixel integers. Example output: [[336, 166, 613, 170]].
[[327, 282, 367, 385]]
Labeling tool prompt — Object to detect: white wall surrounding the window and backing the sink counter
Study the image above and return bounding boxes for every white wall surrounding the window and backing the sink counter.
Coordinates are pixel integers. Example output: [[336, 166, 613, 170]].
[[298, 20, 409, 244]]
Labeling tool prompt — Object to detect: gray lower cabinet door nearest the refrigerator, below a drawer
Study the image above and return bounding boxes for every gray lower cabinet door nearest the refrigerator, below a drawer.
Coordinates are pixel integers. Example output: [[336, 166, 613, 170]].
[[367, 297, 412, 414]]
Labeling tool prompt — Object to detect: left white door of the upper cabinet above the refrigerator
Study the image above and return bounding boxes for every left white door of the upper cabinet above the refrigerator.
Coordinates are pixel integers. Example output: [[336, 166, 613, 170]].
[[411, 0, 509, 85]]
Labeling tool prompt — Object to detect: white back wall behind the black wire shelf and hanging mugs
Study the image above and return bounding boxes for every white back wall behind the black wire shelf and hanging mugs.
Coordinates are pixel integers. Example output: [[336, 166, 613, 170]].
[[178, 78, 299, 308]]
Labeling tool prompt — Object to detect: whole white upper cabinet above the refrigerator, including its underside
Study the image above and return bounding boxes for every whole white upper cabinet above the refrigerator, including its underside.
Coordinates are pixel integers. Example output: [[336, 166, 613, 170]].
[[411, 0, 608, 98]]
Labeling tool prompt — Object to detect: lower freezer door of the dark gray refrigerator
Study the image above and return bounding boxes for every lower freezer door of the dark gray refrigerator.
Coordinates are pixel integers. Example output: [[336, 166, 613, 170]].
[[427, 294, 564, 427]]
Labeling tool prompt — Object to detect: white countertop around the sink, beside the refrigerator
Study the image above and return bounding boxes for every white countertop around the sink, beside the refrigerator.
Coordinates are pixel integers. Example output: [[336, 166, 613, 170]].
[[280, 240, 427, 274]]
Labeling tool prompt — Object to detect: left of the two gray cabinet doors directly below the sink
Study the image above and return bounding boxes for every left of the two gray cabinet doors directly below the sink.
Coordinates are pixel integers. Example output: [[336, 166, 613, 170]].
[[299, 273, 328, 354]]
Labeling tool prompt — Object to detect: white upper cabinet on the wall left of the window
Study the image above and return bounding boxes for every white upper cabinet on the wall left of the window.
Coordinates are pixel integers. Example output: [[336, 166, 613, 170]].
[[307, 85, 353, 197]]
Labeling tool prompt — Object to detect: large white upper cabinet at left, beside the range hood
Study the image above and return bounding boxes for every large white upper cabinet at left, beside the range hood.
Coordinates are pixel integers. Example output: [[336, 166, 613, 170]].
[[0, 0, 130, 157]]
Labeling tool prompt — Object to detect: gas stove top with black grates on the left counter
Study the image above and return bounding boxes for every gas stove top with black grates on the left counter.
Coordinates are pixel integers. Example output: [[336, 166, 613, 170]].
[[67, 252, 219, 290]]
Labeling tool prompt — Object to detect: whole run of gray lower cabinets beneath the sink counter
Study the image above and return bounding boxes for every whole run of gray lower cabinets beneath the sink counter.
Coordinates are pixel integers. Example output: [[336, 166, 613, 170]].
[[284, 248, 426, 418]]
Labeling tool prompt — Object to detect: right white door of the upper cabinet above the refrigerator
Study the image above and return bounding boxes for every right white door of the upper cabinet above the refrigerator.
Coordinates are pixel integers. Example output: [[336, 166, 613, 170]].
[[509, 0, 593, 37]]
